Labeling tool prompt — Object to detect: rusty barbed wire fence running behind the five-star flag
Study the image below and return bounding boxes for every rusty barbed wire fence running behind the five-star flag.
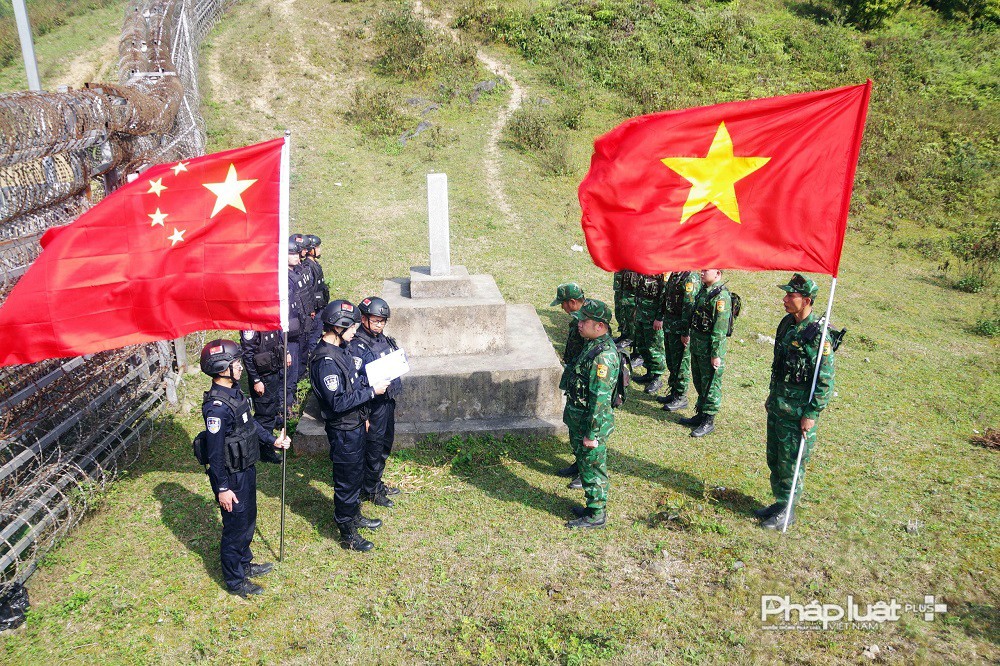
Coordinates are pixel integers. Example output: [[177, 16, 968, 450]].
[[0, 0, 236, 601]]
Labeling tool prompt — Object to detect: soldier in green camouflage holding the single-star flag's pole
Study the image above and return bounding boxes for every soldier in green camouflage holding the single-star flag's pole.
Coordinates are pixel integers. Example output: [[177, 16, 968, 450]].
[[755, 273, 834, 529]]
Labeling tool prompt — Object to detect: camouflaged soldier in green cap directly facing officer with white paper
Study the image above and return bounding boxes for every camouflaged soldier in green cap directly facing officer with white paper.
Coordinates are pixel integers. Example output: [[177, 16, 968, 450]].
[[559, 299, 620, 528]]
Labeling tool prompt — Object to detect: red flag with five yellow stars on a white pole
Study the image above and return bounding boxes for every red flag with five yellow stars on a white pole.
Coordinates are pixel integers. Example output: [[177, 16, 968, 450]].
[[0, 139, 288, 366]]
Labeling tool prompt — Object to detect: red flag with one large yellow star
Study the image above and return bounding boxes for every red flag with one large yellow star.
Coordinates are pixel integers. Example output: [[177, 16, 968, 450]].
[[579, 81, 871, 276]]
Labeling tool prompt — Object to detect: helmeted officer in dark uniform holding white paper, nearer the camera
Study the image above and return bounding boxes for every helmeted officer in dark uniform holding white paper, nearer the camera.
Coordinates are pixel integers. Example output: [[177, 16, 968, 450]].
[[309, 300, 389, 551]]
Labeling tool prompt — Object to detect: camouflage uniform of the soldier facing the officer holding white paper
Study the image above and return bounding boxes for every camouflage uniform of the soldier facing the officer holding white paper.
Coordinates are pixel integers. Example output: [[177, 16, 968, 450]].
[[559, 304, 620, 517]]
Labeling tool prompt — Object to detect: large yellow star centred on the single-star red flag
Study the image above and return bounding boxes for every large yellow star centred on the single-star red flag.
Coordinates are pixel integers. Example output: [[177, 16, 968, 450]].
[[660, 123, 771, 224]]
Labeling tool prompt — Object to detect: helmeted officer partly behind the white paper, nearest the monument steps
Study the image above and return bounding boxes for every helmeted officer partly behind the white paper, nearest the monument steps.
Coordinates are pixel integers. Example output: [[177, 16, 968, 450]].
[[347, 296, 403, 509]]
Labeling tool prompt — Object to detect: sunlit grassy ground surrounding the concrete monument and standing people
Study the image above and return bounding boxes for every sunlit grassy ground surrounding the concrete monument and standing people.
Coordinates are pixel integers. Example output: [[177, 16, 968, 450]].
[[0, 0, 1000, 664]]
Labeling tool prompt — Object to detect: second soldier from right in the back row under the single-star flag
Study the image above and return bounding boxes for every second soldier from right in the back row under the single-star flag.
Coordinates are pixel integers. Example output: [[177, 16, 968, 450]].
[[658, 271, 701, 412]]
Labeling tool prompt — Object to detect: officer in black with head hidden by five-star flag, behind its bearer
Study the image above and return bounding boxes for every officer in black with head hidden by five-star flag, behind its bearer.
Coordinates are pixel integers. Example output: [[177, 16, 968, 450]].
[[240, 330, 288, 463]]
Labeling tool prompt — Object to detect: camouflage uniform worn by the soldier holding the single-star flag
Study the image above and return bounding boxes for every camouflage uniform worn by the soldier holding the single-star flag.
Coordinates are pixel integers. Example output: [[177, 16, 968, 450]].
[[764, 304, 834, 503]]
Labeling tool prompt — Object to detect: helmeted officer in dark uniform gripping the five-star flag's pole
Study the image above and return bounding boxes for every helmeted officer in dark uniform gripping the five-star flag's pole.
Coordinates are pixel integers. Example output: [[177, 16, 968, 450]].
[[201, 340, 290, 598]]
